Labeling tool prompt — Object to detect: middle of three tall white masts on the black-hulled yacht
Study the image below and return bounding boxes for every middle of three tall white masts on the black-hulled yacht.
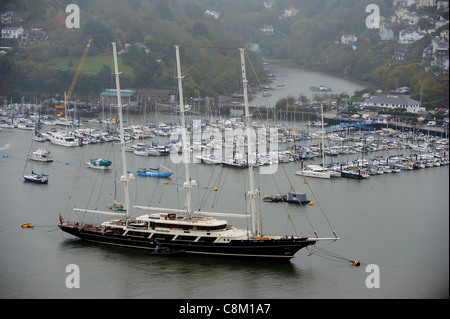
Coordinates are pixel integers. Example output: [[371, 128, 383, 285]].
[[175, 45, 192, 218]]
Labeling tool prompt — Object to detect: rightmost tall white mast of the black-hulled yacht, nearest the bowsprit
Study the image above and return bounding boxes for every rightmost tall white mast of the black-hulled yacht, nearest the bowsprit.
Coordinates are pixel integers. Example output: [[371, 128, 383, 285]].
[[239, 48, 262, 237]]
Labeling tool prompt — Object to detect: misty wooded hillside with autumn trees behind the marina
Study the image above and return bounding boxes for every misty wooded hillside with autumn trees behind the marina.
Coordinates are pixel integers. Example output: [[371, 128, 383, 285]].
[[0, 0, 448, 107]]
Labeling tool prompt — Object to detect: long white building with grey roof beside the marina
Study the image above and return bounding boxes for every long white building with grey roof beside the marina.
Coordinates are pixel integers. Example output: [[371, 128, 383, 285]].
[[362, 96, 426, 113]]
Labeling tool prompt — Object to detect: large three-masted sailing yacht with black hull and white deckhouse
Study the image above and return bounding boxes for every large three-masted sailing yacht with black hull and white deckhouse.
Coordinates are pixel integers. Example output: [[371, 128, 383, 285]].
[[59, 44, 339, 260]]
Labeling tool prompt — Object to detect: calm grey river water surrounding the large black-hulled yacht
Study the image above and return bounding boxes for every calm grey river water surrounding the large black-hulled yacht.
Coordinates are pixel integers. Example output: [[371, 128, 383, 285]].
[[0, 63, 449, 300]]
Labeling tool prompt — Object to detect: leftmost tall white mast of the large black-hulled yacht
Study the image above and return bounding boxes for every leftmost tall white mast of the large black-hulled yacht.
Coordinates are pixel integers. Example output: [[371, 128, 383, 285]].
[[112, 42, 130, 219]]
